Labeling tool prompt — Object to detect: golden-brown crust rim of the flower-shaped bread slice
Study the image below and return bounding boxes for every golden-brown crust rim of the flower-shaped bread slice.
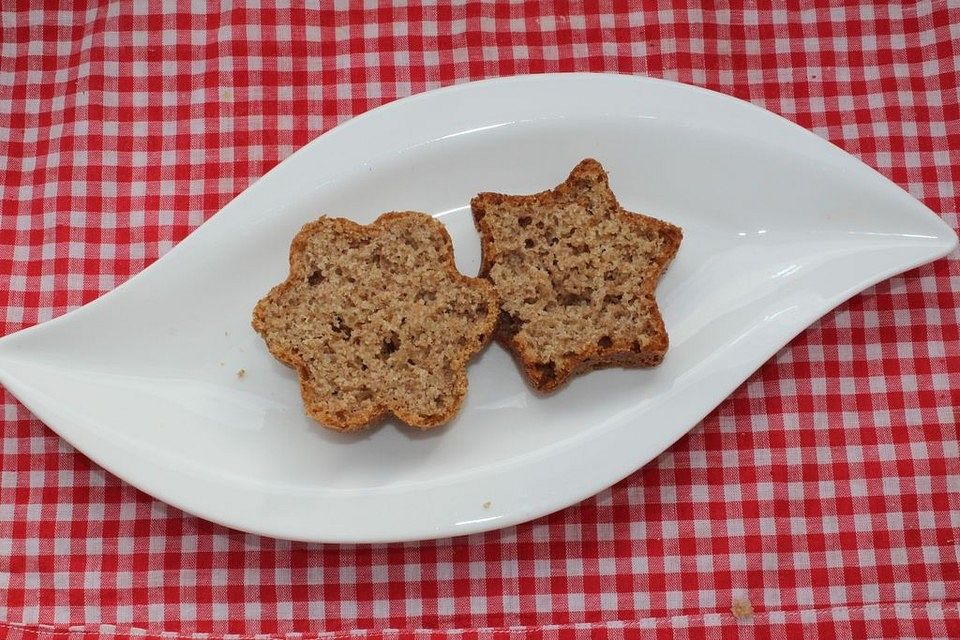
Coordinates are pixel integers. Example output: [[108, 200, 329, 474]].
[[251, 211, 499, 431]]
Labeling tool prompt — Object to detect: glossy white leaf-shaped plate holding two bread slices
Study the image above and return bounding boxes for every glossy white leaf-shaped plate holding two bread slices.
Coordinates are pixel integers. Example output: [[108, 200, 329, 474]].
[[0, 74, 957, 542]]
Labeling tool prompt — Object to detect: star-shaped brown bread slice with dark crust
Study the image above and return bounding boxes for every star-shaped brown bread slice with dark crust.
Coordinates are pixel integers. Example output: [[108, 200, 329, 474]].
[[470, 158, 683, 391]]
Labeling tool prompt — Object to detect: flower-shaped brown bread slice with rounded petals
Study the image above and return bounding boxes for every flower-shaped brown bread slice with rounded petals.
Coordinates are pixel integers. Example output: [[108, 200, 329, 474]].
[[253, 212, 498, 431]]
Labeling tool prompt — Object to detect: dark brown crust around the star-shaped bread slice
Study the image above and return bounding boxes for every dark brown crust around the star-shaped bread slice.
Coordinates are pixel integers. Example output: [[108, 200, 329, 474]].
[[470, 158, 683, 393]]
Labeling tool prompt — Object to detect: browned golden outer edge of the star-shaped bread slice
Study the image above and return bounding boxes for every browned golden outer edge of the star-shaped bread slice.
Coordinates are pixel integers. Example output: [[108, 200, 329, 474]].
[[470, 158, 683, 393]]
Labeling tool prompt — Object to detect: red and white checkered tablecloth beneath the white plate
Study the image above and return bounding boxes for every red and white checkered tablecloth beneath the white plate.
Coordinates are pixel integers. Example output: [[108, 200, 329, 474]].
[[0, 0, 960, 640]]
